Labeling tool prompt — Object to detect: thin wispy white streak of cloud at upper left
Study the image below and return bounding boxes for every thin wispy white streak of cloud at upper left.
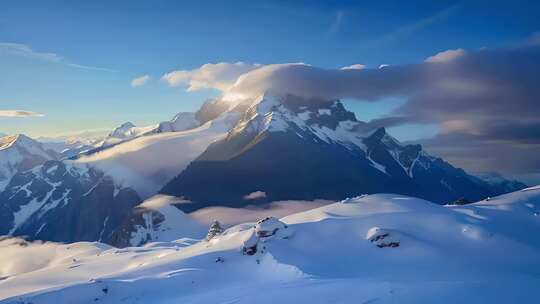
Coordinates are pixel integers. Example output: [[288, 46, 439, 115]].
[[0, 42, 115, 72]]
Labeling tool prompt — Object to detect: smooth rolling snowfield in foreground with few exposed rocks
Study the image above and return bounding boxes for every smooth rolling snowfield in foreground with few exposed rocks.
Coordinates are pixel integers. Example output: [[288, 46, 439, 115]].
[[0, 187, 540, 304]]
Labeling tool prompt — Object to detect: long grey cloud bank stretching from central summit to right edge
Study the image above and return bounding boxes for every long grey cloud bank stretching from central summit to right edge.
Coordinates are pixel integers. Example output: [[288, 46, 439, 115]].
[[164, 41, 540, 178]]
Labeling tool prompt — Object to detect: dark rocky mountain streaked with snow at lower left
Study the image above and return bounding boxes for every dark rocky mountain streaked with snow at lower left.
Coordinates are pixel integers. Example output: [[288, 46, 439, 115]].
[[0, 161, 140, 242]]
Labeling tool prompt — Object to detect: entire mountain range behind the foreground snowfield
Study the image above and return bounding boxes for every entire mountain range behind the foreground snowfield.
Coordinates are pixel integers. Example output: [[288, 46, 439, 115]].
[[0, 94, 526, 245]]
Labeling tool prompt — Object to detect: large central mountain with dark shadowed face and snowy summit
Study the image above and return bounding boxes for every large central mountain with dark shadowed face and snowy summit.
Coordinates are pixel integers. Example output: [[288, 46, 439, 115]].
[[161, 95, 524, 211]]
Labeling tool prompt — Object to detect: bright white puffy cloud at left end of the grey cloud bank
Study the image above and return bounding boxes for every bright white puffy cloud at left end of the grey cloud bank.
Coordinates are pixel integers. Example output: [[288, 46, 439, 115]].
[[162, 62, 260, 91]]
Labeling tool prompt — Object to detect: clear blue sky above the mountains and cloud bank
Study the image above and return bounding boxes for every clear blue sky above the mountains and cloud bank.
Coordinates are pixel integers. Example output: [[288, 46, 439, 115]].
[[0, 0, 540, 139]]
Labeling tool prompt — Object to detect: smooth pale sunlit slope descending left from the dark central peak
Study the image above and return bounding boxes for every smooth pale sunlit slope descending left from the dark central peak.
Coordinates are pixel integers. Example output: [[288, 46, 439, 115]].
[[75, 112, 239, 198]]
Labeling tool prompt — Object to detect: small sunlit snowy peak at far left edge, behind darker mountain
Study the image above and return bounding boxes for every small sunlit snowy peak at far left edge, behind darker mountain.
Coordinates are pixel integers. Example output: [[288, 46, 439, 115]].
[[0, 134, 60, 192]]
